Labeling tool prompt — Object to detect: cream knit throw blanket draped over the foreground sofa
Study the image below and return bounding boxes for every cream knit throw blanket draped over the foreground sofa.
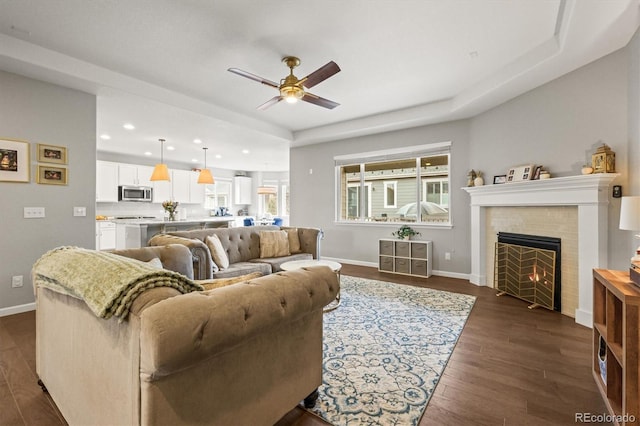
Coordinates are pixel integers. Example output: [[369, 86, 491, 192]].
[[32, 247, 203, 321]]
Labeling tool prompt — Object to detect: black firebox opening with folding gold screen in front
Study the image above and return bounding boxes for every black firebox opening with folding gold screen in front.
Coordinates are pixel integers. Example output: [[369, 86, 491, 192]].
[[494, 232, 561, 311]]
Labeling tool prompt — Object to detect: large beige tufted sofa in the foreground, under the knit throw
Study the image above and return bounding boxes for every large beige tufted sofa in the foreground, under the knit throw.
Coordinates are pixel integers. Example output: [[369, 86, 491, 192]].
[[36, 245, 339, 425]]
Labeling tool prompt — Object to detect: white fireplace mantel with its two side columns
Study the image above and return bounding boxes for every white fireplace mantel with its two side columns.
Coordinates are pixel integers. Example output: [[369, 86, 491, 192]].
[[463, 173, 619, 327]]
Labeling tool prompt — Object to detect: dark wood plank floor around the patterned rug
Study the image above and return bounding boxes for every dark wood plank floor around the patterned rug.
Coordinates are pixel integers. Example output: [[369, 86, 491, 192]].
[[0, 265, 608, 426]]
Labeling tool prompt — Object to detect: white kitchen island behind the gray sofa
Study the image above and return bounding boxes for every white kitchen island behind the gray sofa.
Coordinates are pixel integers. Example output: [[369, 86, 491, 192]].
[[111, 216, 236, 249]]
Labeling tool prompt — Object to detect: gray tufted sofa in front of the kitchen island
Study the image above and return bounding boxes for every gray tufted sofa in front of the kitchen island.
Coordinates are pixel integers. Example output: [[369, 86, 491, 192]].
[[149, 225, 322, 280]]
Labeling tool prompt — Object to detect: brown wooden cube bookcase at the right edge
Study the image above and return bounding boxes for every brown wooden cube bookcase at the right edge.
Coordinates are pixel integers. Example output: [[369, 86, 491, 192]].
[[592, 269, 640, 426]]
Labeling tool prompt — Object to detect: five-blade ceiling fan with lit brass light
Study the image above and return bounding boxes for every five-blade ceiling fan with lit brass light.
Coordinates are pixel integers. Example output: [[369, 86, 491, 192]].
[[229, 56, 340, 110]]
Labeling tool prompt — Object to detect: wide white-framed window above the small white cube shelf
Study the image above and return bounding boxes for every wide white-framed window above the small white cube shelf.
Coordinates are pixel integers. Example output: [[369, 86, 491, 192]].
[[335, 142, 451, 225]]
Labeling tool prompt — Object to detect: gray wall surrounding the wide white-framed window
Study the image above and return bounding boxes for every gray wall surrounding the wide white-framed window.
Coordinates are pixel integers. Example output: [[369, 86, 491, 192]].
[[290, 120, 471, 274]]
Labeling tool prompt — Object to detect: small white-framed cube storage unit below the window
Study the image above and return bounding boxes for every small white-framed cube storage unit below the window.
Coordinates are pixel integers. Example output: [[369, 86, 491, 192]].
[[378, 239, 432, 277]]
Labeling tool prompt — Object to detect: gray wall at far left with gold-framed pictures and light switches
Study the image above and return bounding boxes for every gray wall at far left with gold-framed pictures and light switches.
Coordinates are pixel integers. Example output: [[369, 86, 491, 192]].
[[0, 71, 96, 315]]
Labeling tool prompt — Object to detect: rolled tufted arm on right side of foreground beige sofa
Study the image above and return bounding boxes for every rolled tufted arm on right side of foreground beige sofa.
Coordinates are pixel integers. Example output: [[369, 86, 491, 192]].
[[140, 266, 339, 380]]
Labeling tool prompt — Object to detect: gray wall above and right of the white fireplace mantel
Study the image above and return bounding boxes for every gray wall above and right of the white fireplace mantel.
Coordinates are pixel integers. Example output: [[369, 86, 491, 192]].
[[469, 49, 632, 269]]
